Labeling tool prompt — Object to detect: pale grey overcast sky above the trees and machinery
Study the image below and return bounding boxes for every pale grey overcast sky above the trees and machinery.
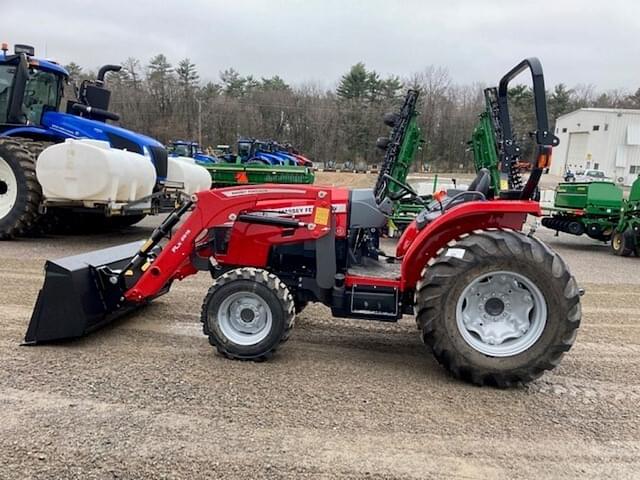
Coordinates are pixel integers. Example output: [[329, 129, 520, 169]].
[[5, 0, 640, 90]]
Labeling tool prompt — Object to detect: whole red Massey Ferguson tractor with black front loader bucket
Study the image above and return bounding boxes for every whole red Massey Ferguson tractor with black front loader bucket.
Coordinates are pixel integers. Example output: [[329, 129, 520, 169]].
[[25, 59, 581, 386]]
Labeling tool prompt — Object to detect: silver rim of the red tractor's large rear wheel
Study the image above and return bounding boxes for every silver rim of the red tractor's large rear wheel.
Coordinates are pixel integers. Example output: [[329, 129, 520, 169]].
[[456, 271, 547, 357]]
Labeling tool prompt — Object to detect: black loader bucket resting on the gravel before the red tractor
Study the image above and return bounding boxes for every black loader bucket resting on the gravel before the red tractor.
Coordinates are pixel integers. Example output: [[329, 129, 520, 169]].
[[24, 242, 146, 345]]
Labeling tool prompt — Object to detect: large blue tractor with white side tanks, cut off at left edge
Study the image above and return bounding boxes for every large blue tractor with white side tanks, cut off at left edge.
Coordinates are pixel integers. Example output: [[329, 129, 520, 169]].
[[0, 44, 210, 239]]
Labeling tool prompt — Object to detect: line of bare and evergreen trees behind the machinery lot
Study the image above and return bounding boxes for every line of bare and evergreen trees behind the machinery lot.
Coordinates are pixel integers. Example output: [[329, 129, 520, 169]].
[[66, 54, 640, 171]]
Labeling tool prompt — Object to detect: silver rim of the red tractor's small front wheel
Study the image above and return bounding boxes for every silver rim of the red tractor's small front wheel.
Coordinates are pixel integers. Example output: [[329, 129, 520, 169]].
[[217, 292, 273, 345]]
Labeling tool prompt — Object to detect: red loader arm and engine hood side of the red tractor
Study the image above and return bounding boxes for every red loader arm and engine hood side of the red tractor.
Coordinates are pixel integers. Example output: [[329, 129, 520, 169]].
[[122, 185, 331, 303]]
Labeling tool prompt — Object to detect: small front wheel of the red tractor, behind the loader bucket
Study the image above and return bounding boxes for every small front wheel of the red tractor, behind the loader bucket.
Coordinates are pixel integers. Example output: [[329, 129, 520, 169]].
[[201, 268, 295, 361]]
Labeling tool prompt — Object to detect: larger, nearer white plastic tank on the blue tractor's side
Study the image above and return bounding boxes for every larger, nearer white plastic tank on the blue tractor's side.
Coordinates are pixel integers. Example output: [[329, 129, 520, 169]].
[[36, 139, 156, 202]]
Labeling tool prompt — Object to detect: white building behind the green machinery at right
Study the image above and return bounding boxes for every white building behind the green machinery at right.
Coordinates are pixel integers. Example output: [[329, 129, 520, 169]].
[[550, 108, 640, 185]]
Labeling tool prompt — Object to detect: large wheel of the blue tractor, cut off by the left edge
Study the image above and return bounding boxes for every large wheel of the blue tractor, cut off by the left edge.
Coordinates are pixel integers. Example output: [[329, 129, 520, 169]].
[[0, 138, 48, 240]]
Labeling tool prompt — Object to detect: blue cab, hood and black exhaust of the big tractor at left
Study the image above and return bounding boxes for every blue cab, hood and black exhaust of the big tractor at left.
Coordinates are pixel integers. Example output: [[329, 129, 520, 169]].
[[0, 45, 167, 182]]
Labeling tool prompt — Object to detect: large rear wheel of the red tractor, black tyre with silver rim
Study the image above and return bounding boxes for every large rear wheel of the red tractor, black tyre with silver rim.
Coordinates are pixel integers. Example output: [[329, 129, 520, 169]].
[[417, 230, 581, 387]]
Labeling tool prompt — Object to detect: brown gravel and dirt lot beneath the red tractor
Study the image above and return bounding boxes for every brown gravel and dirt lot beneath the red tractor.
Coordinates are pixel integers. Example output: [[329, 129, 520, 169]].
[[0, 177, 640, 479]]
